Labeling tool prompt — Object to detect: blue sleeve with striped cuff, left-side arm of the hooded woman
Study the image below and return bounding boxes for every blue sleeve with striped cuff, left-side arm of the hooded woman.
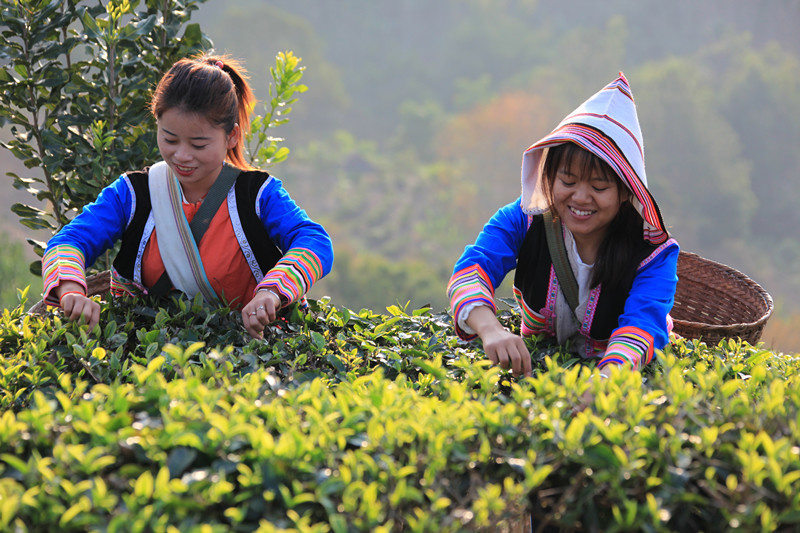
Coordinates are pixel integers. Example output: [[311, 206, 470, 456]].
[[447, 199, 528, 340]]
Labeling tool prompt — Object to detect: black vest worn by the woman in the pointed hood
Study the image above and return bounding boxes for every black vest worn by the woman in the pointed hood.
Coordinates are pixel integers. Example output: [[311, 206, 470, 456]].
[[514, 215, 657, 340]]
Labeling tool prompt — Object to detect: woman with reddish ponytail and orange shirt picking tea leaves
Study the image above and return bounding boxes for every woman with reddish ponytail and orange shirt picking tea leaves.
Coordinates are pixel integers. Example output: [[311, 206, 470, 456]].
[[42, 54, 333, 338]]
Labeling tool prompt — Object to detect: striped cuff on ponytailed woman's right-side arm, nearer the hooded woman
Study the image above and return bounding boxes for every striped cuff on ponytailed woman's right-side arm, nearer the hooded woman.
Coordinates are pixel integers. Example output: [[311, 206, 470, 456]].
[[254, 248, 322, 305]]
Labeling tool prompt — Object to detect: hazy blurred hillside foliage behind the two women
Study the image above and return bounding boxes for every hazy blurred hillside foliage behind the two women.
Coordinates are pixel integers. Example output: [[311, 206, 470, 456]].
[[0, 0, 800, 352]]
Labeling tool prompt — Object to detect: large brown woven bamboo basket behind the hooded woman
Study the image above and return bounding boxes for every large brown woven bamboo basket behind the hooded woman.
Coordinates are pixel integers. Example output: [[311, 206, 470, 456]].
[[670, 252, 773, 344]]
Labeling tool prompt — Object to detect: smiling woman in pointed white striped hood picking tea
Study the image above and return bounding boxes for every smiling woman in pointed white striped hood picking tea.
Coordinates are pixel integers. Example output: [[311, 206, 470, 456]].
[[448, 75, 679, 376]]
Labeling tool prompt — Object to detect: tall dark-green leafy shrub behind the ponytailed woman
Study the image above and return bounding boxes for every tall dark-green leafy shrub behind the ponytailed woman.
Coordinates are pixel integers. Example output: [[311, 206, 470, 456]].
[[0, 0, 211, 273]]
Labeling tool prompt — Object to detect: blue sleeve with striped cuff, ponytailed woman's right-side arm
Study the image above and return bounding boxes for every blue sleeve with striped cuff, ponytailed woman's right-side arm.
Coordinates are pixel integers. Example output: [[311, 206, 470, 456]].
[[255, 178, 333, 305]]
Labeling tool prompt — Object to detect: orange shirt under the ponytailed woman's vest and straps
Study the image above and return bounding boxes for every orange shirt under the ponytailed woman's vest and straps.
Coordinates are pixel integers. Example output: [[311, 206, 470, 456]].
[[142, 199, 261, 309]]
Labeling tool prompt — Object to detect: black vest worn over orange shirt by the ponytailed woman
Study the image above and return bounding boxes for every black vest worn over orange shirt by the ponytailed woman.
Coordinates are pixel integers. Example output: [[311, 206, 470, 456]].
[[114, 167, 283, 281]]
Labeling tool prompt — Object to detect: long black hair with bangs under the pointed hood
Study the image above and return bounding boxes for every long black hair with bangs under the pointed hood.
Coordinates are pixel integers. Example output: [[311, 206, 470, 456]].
[[542, 142, 644, 290]]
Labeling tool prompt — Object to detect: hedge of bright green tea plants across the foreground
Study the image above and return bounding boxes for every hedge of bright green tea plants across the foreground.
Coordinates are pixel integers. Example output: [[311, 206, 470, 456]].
[[0, 288, 800, 533]]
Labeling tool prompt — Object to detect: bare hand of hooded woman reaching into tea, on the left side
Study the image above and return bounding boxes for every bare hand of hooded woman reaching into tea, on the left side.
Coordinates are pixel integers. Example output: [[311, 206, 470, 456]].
[[467, 306, 532, 376]]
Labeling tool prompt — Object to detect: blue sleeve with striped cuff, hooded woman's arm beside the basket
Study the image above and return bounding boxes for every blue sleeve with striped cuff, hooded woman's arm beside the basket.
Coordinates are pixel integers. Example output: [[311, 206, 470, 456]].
[[597, 239, 680, 370]]
